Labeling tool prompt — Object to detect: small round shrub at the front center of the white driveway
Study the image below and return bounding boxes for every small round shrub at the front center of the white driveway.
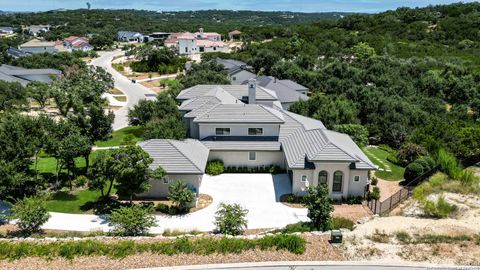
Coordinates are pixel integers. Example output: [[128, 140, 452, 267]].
[[215, 203, 248, 235]]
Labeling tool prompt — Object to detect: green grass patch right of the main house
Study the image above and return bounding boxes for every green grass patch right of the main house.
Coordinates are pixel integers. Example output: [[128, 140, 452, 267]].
[[363, 147, 405, 181]]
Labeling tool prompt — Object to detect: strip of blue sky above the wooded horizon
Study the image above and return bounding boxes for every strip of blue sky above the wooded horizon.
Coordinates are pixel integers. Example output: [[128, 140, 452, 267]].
[[0, 0, 474, 13]]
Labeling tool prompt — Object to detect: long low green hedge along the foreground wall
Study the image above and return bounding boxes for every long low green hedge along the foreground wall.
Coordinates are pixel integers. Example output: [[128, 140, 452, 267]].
[[0, 234, 306, 260]]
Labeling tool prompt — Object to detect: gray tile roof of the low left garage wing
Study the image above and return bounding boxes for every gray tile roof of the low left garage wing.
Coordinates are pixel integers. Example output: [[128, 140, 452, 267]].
[[138, 139, 209, 174]]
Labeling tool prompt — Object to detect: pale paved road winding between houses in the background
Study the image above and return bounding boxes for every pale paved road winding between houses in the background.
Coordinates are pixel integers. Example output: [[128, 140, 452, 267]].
[[91, 50, 156, 130]]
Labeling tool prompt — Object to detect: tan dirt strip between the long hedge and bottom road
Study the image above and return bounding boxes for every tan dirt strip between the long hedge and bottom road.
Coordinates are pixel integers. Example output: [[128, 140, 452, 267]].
[[0, 234, 344, 270]]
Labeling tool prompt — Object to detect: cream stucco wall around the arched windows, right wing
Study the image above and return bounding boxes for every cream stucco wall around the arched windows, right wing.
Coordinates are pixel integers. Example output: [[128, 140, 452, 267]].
[[292, 162, 368, 199]]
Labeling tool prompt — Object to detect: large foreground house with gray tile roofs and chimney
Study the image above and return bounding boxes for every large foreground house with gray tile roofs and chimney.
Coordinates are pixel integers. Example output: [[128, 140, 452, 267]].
[[139, 79, 375, 199]]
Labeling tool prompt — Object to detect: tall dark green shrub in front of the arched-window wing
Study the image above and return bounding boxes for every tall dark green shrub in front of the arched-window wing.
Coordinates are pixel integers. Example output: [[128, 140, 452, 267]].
[[303, 184, 333, 231]]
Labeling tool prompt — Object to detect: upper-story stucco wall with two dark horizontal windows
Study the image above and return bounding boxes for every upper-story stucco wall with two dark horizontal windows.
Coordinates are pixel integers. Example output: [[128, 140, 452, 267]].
[[198, 123, 280, 139]]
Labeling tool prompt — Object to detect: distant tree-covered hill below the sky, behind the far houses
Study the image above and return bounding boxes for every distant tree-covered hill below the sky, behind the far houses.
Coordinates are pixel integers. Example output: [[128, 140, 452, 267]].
[[0, 9, 349, 39]]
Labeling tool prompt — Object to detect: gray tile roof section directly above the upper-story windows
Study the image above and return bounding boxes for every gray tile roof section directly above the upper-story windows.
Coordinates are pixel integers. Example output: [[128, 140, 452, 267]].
[[193, 104, 284, 124]]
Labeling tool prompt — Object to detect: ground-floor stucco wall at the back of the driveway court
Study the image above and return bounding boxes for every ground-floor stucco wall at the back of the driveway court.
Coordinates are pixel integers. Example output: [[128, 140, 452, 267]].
[[208, 151, 285, 169]]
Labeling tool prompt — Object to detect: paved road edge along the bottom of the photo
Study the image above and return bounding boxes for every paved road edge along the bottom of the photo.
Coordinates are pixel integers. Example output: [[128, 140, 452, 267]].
[[130, 261, 458, 270]]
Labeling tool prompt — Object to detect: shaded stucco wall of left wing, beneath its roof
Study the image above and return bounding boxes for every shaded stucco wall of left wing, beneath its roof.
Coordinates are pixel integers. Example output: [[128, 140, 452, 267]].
[[136, 174, 203, 198]]
